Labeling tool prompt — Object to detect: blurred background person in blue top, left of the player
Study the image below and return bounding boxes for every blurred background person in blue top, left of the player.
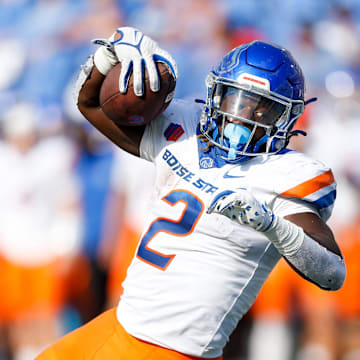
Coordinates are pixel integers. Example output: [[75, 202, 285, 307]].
[[68, 117, 124, 323]]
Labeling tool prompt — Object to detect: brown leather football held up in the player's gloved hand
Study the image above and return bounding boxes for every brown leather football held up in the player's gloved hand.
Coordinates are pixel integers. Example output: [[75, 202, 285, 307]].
[[100, 62, 176, 126]]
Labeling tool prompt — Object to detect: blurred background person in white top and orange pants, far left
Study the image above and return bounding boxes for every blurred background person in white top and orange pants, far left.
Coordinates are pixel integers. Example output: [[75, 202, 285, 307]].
[[0, 103, 81, 360]]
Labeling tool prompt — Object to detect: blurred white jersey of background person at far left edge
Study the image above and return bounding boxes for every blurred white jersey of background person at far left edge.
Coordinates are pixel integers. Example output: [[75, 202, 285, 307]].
[[0, 137, 82, 266]]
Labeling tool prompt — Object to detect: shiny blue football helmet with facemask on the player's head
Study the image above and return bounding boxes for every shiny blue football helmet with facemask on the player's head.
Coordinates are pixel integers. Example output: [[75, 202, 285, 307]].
[[200, 41, 305, 163]]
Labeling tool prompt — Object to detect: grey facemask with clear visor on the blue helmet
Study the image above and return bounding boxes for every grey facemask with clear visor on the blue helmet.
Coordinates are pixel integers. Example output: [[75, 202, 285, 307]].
[[200, 72, 304, 162]]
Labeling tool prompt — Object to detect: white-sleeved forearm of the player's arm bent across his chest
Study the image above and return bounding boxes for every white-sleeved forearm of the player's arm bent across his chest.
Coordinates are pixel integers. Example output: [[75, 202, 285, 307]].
[[264, 216, 346, 290]]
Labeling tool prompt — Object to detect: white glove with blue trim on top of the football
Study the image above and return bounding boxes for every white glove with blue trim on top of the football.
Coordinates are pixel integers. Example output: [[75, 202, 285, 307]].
[[93, 27, 178, 96]]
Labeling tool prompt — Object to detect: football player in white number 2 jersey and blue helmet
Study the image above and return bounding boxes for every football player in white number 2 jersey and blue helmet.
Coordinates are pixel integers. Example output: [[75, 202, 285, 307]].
[[40, 27, 346, 360]]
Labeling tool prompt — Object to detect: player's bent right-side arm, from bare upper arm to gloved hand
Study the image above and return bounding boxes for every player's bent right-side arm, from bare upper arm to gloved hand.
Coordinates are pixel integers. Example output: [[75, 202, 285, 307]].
[[208, 190, 346, 290]]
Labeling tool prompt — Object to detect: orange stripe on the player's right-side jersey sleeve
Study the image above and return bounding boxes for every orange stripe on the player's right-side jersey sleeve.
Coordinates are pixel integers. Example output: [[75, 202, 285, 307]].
[[280, 170, 335, 198]]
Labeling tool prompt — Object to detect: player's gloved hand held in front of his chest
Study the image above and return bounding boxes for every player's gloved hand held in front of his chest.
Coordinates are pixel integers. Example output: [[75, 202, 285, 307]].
[[207, 189, 274, 231]]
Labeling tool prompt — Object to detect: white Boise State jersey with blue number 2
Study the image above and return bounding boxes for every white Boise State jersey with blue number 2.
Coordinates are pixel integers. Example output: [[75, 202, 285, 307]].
[[117, 100, 336, 358]]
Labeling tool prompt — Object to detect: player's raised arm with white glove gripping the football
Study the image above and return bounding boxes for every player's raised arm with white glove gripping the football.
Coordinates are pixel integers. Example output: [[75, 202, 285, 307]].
[[75, 27, 177, 156]]
